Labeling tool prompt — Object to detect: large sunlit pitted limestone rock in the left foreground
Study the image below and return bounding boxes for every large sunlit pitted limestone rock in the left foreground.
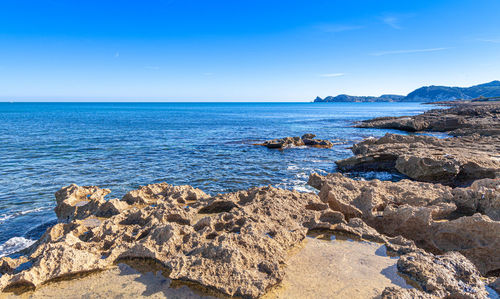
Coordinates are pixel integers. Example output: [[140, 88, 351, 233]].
[[0, 184, 345, 298]]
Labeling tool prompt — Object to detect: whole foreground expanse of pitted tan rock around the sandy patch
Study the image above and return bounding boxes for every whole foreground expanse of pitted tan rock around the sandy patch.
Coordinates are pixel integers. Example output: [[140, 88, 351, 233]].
[[0, 178, 500, 298]]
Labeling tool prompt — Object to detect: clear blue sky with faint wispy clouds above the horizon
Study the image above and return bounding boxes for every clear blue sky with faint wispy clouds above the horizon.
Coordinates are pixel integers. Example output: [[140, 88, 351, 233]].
[[0, 0, 500, 101]]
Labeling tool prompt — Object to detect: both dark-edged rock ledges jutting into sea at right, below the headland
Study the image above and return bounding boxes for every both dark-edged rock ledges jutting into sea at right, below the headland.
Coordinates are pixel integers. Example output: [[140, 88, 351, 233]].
[[336, 102, 500, 186]]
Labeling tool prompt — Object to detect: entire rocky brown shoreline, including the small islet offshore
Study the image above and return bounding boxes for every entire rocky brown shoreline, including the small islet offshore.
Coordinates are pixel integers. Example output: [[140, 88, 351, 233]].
[[0, 103, 500, 298]]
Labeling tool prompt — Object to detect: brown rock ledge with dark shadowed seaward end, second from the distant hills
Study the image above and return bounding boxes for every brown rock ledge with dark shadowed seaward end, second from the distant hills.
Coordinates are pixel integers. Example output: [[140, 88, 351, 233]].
[[335, 134, 500, 186]]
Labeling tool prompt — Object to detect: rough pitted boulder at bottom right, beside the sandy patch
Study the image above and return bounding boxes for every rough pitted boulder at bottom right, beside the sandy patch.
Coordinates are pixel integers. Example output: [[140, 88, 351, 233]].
[[398, 252, 487, 298]]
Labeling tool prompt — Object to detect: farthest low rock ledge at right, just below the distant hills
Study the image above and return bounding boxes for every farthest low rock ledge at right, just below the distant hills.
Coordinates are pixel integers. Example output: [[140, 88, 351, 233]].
[[356, 101, 500, 136]]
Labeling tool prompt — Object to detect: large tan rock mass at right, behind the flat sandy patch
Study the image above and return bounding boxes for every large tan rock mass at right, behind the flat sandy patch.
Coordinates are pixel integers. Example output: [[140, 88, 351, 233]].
[[311, 173, 500, 274]]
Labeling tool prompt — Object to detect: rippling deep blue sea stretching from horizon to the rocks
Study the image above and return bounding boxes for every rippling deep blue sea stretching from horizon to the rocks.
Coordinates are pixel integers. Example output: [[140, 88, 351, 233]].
[[0, 103, 433, 256]]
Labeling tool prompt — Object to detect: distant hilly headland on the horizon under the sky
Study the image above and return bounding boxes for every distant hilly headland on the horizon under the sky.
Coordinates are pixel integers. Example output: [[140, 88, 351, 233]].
[[314, 81, 500, 102]]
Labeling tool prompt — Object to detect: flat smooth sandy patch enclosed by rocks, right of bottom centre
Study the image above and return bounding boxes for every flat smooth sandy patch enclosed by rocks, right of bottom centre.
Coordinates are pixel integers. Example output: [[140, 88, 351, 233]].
[[264, 238, 412, 299]]
